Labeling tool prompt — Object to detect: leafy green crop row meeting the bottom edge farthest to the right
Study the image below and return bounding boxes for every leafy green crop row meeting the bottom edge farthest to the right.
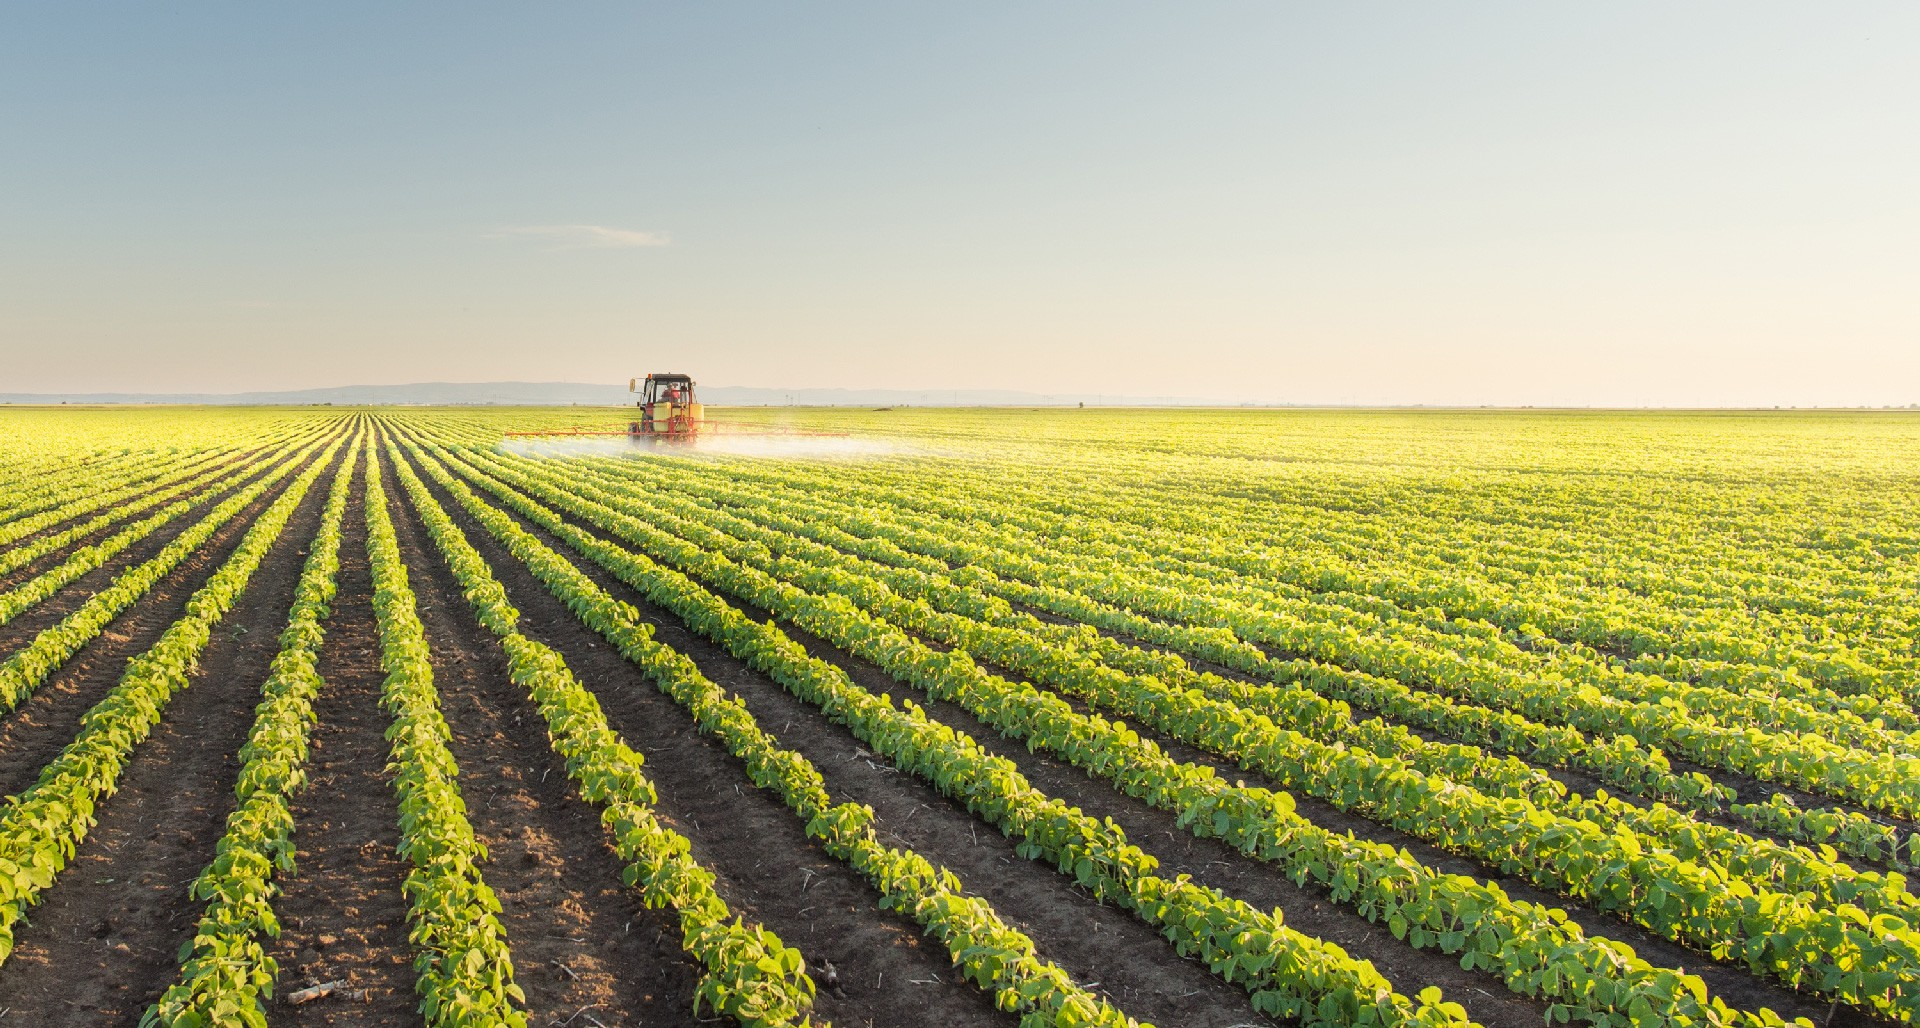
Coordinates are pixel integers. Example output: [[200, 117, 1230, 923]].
[[439, 440, 1812, 1024]]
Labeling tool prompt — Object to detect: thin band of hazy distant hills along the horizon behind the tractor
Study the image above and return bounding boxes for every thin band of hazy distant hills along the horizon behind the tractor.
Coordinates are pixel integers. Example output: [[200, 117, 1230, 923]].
[[0, 382, 1231, 407]]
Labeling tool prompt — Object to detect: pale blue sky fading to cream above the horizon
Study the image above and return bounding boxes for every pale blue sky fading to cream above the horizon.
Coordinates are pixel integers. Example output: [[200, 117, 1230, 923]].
[[0, 2, 1920, 405]]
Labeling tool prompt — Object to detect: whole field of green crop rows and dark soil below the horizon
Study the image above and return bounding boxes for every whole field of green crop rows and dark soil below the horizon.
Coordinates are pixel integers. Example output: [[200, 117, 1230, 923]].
[[0, 407, 1920, 1028]]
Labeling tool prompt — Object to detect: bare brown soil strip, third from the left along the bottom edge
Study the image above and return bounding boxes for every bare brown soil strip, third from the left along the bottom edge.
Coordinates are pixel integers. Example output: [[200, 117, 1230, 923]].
[[386, 455, 697, 1024]]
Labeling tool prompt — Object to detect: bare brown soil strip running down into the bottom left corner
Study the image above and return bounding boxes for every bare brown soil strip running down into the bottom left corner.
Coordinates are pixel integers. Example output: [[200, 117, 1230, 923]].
[[0, 440, 341, 1024]]
